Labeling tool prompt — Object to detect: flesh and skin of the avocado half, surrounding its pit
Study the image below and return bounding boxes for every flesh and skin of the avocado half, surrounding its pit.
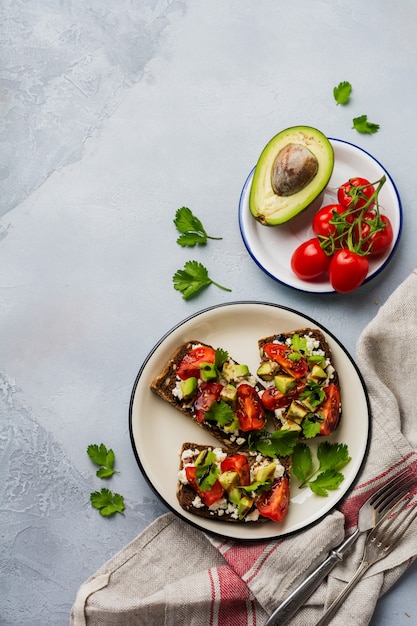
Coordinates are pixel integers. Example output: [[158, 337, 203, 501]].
[[249, 126, 334, 226]]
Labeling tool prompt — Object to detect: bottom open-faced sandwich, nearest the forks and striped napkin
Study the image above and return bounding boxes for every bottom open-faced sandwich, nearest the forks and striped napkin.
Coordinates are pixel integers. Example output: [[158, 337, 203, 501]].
[[177, 443, 290, 523]]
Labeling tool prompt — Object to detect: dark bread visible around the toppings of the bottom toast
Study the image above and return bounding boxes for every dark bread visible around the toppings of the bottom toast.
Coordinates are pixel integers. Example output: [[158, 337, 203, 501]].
[[177, 442, 290, 524]]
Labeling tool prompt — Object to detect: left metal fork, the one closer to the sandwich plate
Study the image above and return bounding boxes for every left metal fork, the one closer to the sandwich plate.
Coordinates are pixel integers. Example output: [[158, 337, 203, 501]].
[[265, 469, 417, 626]]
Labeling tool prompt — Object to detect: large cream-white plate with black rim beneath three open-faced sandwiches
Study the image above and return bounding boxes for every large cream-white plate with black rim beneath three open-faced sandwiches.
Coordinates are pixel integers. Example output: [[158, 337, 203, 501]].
[[129, 302, 369, 539]]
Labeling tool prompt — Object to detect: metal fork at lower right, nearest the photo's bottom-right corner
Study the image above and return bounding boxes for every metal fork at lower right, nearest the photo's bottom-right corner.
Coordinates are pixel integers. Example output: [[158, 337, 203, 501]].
[[316, 496, 417, 626]]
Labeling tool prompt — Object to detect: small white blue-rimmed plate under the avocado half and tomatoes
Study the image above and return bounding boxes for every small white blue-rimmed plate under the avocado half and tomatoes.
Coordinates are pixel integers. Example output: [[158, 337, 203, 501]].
[[239, 139, 402, 293]]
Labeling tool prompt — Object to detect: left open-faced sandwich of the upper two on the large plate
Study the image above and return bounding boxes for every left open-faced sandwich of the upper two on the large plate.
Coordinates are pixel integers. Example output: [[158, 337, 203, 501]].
[[151, 341, 267, 450]]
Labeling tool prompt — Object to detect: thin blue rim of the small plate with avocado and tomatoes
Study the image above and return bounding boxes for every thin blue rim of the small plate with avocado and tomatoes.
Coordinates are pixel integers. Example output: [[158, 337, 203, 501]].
[[238, 137, 403, 294]]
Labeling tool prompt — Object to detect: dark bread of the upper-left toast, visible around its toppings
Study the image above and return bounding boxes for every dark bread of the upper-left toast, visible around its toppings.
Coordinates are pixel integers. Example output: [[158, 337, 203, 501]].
[[151, 340, 268, 451]]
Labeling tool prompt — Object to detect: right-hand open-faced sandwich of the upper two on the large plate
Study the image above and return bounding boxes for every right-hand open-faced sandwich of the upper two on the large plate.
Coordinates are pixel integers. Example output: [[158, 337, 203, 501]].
[[257, 328, 342, 439]]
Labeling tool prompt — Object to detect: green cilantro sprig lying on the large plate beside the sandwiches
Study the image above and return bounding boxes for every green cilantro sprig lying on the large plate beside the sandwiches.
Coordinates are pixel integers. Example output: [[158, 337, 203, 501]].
[[292, 441, 351, 497]]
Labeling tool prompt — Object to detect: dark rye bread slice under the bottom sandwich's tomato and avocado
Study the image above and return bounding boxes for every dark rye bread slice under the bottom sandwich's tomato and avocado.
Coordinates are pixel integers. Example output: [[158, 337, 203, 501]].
[[177, 442, 291, 524]]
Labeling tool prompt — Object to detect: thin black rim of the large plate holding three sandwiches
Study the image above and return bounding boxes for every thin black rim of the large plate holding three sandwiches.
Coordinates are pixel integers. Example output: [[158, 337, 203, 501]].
[[129, 300, 372, 542]]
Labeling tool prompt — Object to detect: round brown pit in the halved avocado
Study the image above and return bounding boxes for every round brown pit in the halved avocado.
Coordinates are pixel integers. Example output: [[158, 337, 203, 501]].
[[271, 143, 319, 196]]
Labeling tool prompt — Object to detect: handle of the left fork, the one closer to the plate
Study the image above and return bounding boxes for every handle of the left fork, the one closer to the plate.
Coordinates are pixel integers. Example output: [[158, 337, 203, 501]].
[[265, 528, 360, 626]]
